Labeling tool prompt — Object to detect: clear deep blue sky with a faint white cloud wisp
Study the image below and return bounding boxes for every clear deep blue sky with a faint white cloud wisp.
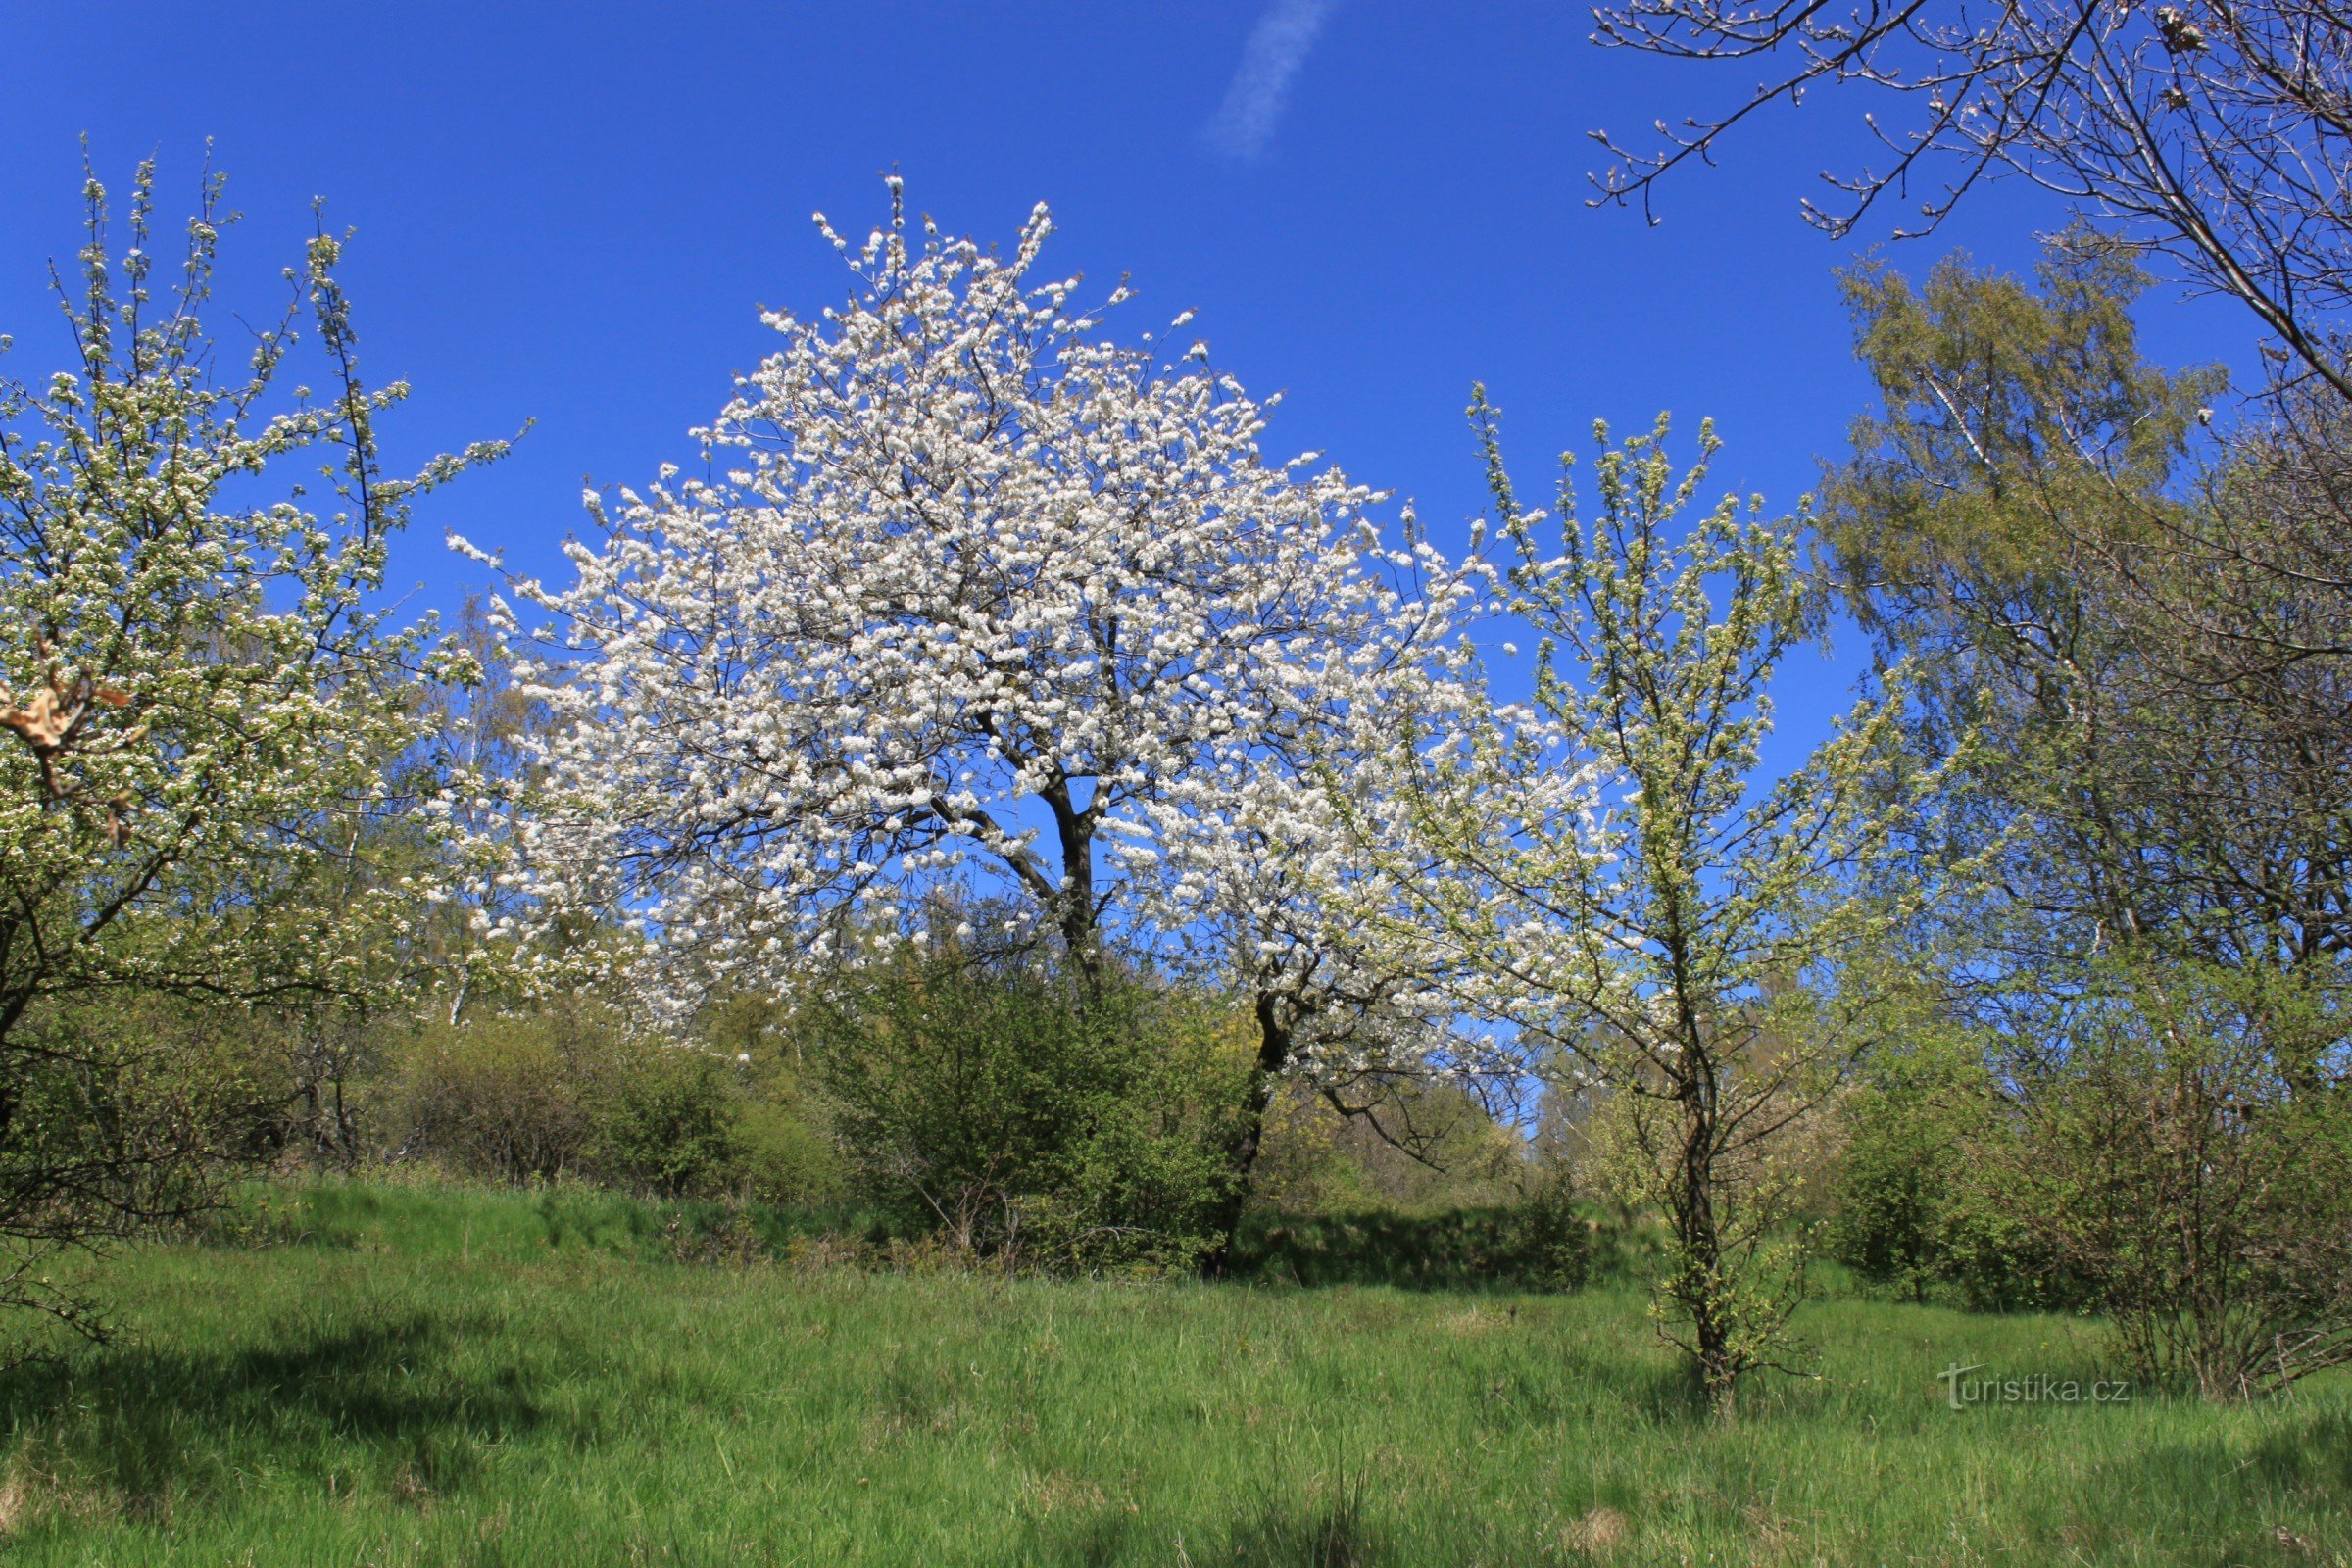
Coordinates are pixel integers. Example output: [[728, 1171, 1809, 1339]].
[[0, 0, 2248, 747]]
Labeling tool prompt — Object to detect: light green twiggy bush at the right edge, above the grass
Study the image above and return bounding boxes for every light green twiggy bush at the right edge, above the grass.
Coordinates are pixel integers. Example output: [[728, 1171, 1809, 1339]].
[[2018, 961, 2352, 1398]]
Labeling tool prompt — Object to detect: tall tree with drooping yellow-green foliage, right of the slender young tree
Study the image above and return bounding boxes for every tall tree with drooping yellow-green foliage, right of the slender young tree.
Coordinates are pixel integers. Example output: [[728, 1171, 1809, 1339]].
[[1823, 252, 2216, 953]]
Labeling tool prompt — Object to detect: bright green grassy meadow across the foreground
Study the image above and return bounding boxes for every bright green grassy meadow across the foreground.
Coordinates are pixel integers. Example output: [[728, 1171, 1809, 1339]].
[[0, 1187, 2352, 1568]]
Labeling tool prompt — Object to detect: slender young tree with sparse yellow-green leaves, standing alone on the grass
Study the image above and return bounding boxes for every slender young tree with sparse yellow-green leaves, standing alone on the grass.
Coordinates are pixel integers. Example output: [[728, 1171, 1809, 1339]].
[[1366, 395, 1956, 1415]]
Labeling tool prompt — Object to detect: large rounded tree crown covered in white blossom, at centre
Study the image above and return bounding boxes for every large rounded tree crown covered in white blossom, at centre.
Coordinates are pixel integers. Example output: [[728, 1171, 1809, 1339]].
[[461, 181, 1468, 1175]]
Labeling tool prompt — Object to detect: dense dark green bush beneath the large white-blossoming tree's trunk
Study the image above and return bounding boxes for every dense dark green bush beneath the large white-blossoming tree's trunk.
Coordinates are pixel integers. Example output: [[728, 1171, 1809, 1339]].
[[809, 953, 1249, 1269]]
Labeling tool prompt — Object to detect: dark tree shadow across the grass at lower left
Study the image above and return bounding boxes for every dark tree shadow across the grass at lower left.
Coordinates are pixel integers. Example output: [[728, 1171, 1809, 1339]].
[[0, 1312, 546, 1516]]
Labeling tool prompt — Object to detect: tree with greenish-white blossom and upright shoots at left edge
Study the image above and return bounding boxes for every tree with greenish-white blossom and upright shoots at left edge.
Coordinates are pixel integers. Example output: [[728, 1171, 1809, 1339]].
[[0, 165, 499, 1314]]
